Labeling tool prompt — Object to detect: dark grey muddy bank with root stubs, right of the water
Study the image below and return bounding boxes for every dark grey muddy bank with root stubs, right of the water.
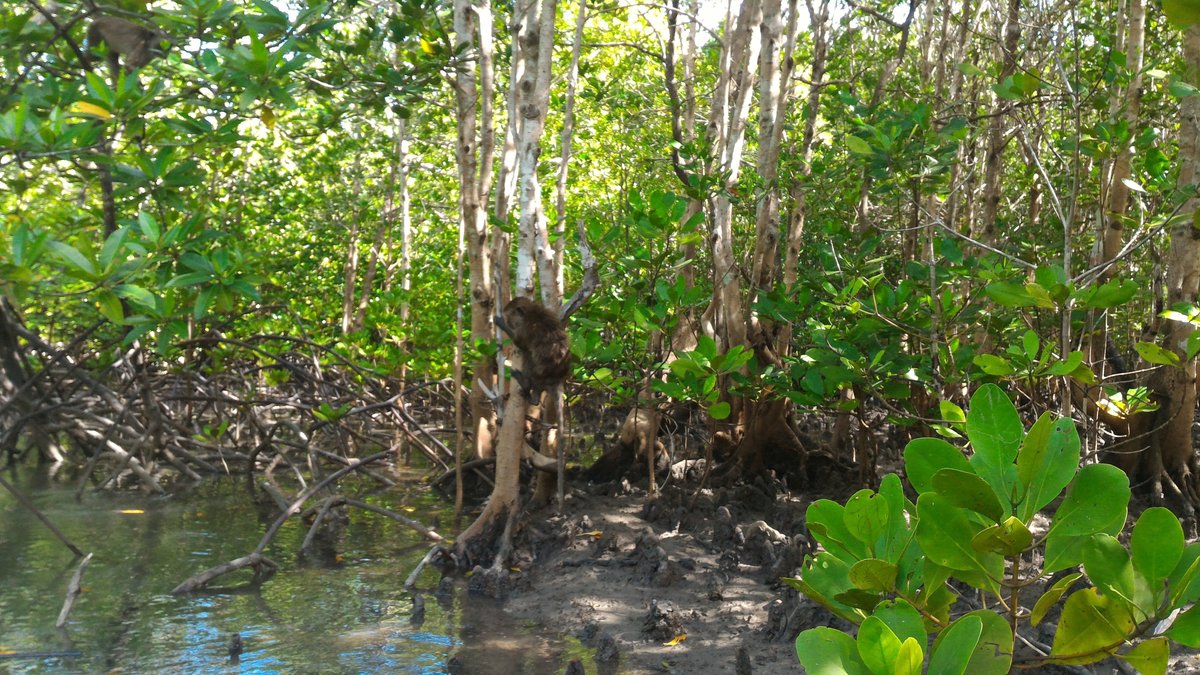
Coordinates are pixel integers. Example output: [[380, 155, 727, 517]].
[[474, 468, 838, 675]]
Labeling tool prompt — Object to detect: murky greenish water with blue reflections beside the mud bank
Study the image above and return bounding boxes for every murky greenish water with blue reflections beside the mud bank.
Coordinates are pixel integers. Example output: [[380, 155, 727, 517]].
[[0, 471, 595, 674]]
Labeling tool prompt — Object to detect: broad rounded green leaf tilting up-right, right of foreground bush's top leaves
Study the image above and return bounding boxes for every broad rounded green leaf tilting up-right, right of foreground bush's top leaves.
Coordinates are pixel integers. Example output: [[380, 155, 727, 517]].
[[1046, 464, 1129, 535]]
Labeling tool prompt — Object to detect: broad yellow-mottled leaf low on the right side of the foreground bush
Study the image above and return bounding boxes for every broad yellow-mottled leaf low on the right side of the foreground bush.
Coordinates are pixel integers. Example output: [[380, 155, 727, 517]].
[[1050, 589, 1135, 665]]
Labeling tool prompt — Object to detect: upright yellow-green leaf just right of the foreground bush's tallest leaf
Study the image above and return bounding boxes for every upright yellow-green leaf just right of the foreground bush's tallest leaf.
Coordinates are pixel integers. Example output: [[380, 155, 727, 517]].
[[1016, 413, 1080, 522]]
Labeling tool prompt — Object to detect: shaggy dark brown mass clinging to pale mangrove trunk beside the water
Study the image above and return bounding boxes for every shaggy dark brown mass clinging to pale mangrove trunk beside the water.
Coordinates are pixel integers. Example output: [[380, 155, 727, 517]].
[[496, 298, 571, 401]]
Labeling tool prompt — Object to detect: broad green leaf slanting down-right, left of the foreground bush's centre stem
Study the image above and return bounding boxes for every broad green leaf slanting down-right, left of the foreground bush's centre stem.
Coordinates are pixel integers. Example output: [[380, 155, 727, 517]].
[[917, 492, 1004, 587]]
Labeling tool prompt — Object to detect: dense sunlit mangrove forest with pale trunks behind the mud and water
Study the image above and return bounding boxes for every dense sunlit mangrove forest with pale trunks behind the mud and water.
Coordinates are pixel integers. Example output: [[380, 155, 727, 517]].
[[0, 0, 1200, 667]]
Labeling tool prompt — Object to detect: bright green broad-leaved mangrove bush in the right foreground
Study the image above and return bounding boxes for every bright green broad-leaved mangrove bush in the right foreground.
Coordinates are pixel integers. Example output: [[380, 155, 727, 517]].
[[787, 384, 1200, 674]]
